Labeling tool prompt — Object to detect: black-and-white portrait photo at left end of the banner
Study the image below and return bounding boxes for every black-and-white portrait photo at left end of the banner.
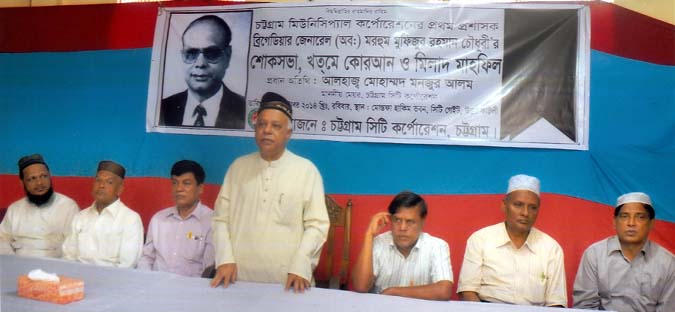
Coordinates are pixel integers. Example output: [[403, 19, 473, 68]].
[[153, 10, 252, 133]]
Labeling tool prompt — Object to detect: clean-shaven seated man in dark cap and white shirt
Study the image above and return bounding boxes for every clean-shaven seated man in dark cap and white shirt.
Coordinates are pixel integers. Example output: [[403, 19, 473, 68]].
[[63, 160, 143, 268]]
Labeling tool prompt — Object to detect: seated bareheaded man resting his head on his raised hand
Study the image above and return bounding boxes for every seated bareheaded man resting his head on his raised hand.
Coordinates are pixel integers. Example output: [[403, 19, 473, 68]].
[[352, 192, 452, 300]]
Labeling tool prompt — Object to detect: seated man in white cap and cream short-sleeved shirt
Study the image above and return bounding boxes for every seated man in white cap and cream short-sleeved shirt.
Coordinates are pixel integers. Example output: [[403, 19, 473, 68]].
[[457, 174, 567, 307]]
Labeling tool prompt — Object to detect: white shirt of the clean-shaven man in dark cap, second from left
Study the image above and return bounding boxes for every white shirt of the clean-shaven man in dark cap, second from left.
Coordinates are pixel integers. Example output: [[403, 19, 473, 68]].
[[63, 199, 143, 267]]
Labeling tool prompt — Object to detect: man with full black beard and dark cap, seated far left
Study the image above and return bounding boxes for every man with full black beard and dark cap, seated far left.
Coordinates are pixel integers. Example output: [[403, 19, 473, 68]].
[[0, 154, 80, 258]]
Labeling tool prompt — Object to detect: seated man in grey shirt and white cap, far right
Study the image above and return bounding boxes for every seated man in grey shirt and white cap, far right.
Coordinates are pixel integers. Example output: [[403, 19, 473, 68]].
[[574, 193, 675, 312]]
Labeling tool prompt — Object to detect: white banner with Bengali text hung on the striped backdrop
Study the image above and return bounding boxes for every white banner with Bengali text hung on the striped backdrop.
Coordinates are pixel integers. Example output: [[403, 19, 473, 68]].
[[146, 4, 590, 149]]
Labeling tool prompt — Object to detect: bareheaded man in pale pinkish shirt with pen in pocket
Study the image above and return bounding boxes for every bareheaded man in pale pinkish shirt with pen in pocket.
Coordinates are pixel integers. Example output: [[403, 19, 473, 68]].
[[138, 160, 215, 277]]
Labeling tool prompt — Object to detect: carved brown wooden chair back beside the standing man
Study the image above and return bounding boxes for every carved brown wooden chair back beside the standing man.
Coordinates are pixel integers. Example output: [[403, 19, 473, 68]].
[[316, 195, 352, 289]]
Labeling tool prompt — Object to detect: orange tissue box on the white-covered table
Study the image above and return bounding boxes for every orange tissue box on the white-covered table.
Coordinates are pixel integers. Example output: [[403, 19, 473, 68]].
[[17, 275, 84, 304]]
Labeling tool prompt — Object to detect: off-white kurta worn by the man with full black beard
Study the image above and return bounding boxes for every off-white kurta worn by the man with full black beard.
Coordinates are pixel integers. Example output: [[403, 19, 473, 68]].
[[0, 192, 80, 258]]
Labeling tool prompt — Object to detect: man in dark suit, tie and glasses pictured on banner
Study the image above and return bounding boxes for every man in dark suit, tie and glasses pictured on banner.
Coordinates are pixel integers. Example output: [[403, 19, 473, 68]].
[[159, 15, 246, 129]]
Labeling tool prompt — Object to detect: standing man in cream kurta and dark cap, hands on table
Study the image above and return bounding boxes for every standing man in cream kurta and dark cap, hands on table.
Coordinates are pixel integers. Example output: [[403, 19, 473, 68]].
[[211, 92, 329, 292]]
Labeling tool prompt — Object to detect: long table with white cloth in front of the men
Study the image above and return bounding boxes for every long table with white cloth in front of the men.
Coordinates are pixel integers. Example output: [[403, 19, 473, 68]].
[[0, 255, 588, 312]]
